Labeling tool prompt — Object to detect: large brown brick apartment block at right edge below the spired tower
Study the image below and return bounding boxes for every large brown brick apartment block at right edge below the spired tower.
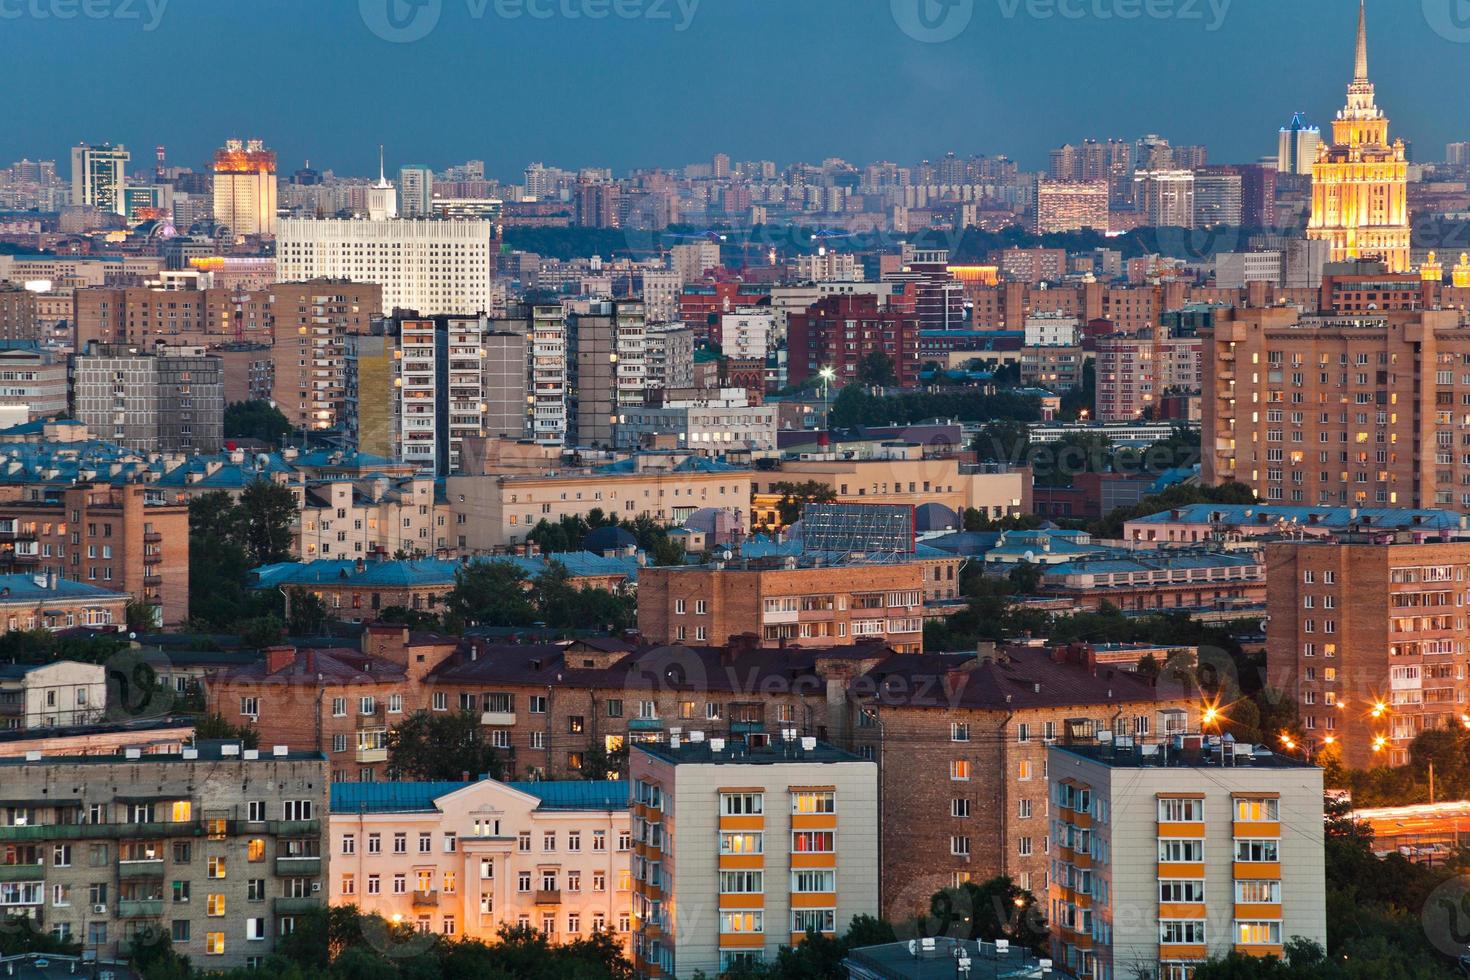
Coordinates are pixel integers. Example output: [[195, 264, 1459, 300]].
[[1201, 309, 1470, 510]]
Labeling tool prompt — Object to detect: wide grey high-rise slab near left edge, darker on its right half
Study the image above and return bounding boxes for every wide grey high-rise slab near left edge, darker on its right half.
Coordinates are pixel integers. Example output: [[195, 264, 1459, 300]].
[[74, 344, 225, 453]]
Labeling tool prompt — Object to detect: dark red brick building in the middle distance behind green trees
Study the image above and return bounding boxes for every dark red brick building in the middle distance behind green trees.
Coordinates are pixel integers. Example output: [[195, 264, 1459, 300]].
[[786, 294, 920, 388]]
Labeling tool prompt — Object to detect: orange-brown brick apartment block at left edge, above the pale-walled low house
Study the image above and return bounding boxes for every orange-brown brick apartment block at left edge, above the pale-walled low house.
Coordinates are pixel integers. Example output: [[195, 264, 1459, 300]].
[[0, 483, 188, 626]]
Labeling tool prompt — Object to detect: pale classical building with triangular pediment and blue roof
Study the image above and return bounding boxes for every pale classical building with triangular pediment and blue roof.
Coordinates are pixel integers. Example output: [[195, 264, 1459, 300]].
[[328, 775, 632, 943]]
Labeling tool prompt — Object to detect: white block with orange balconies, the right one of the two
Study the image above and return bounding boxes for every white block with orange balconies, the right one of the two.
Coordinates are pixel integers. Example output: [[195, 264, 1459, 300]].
[[1047, 735, 1327, 980]]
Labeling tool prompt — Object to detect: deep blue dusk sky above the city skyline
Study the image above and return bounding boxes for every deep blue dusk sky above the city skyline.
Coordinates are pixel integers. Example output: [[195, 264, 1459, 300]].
[[11, 0, 1470, 179]]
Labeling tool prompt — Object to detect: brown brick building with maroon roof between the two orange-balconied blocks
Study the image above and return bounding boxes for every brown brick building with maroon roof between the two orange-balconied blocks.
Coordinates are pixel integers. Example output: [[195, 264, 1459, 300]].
[[851, 646, 1200, 921]]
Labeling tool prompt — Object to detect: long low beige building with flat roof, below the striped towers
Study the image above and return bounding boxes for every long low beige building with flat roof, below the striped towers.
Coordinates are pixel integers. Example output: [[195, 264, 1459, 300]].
[[445, 453, 754, 552]]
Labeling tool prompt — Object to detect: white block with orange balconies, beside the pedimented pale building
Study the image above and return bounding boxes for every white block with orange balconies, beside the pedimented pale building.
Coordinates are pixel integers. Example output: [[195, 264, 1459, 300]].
[[629, 740, 878, 979]]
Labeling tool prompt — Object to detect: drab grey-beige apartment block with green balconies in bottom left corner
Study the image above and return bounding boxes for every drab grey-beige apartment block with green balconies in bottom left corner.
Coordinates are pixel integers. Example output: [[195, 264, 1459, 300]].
[[0, 743, 326, 970]]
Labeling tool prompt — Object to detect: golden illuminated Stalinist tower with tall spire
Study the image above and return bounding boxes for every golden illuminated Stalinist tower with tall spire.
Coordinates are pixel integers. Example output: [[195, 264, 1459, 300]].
[[1307, 0, 1410, 272]]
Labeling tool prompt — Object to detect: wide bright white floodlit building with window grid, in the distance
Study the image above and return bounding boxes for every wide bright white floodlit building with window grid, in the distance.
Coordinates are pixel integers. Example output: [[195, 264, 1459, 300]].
[[276, 217, 492, 316]]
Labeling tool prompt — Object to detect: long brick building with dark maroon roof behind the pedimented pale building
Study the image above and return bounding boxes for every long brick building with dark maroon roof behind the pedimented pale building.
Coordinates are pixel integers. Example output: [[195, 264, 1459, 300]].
[[207, 626, 891, 782]]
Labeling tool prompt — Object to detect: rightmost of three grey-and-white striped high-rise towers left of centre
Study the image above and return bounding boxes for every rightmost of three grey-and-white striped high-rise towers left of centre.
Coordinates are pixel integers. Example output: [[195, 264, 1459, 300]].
[[567, 300, 648, 447]]
